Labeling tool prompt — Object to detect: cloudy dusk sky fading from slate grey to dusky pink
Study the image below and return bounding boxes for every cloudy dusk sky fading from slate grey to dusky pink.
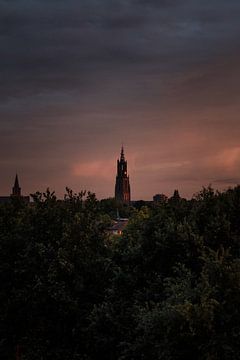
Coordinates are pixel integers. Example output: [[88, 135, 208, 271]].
[[0, 0, 240, 200]]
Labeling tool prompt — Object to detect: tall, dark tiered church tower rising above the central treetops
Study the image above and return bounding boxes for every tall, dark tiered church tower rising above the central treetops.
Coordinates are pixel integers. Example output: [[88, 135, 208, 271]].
[[115, 146, 131, 204]]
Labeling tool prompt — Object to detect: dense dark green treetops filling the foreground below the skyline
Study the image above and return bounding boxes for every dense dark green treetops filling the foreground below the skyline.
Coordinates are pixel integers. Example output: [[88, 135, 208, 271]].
[[0, 187, 240, 360]]
